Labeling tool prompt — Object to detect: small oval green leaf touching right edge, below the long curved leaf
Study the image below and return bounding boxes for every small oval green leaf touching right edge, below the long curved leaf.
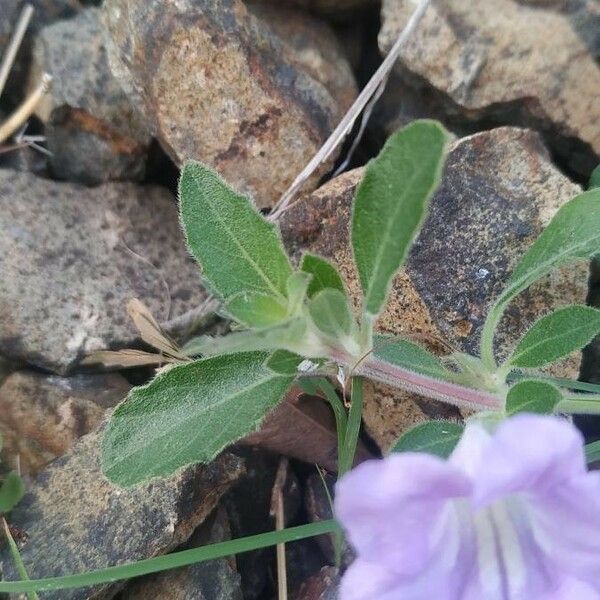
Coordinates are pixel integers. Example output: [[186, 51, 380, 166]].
[[508, 305, 600, 368]]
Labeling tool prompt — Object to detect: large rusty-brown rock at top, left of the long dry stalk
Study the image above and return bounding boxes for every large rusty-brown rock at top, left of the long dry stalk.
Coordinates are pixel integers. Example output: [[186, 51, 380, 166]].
[[104, 0, 355, 208]]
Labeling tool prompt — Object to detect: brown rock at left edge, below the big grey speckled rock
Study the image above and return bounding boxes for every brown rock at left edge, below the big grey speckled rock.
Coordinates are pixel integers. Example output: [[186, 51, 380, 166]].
[[0, 371, 131, 477]]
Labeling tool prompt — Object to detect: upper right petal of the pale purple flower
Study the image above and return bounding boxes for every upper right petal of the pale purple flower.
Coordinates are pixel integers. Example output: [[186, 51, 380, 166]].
[[473, 414, 586, 507]]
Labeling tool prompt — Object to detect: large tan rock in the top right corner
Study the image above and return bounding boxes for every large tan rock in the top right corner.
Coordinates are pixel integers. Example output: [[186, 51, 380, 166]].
[[379, 0, 600, 175]]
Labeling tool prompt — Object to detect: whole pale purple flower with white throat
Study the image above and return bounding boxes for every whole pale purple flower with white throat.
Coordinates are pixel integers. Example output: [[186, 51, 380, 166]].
[[335, 414, 600, 600]]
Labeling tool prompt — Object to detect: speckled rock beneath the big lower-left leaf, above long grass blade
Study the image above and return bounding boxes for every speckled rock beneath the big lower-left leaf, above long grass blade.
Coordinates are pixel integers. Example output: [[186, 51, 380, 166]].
[[0, 430, 243, 600]]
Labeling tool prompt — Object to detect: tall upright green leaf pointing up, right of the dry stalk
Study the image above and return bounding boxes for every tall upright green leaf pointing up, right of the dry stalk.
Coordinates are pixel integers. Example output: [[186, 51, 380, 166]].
[[352, 121, 449, 315]]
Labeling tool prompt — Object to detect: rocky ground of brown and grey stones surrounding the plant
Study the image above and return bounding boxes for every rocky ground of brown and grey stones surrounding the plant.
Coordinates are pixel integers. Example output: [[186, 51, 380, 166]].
[[0, 0, 600, 600]]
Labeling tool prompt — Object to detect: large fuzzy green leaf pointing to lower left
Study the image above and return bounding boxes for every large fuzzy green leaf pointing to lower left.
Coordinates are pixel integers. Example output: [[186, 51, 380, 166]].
[[102, 352, 293, 486]]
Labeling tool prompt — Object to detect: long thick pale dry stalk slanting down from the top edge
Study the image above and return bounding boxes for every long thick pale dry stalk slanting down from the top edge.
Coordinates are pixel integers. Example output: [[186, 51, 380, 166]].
[[269, 0, 431, 221]]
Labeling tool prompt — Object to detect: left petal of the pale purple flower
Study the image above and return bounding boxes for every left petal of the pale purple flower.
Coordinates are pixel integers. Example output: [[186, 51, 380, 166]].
[[335, 453, 471, 576]]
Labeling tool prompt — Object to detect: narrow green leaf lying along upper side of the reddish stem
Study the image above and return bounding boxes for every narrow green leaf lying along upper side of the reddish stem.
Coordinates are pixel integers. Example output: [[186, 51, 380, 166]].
[[373, 335, 454, 379]]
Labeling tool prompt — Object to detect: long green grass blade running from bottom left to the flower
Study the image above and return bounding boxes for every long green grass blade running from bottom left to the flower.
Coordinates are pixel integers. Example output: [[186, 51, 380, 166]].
[[0, 519, 340, 594]]
